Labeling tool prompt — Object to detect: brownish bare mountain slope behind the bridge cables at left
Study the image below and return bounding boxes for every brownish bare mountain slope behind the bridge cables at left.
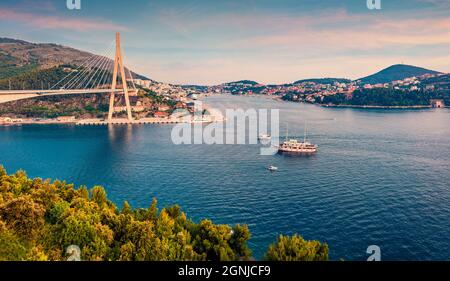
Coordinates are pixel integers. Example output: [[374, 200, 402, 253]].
[[0, 38, 149, 79]]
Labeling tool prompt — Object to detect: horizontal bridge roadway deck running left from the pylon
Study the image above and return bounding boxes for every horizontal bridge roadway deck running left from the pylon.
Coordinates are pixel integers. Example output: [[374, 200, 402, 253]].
[[0, 89, 137, 103]]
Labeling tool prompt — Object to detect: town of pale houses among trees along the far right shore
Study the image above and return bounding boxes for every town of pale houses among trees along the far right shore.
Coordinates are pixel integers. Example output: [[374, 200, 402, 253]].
[[185, 69, 450, 108]]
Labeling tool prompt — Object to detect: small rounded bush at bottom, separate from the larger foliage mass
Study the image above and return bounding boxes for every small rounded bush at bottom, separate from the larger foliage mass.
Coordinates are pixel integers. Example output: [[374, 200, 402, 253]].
[[265, 235, 328, 261]]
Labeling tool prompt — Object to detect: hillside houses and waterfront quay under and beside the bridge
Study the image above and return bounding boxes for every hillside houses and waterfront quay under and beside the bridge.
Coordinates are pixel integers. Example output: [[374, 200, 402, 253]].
[[0, 76, 223, 125]]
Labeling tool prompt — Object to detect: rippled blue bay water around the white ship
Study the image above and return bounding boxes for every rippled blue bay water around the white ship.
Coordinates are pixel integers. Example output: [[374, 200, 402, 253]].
[[0, 96, 450, 260]]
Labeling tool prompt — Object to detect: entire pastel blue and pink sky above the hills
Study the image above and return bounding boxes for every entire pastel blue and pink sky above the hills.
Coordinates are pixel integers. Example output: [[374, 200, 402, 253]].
[[0, 0, 450, 85]]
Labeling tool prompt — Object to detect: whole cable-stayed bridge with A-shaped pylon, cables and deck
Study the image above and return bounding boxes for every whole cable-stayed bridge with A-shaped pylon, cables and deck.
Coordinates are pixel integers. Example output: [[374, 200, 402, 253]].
[[0, 33, 137, 123]]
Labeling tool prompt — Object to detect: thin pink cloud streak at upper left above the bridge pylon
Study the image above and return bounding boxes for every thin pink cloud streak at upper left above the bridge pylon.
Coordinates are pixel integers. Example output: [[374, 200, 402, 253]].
[[0, 9, 126, 32]]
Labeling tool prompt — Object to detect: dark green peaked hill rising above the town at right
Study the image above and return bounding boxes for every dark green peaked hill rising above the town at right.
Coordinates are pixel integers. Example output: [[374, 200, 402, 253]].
[[358, 64, 440, 84]]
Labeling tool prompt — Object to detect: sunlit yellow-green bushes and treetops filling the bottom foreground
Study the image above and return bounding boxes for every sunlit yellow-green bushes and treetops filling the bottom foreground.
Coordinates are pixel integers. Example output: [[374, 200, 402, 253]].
[[0, 166, 328, 261]]
